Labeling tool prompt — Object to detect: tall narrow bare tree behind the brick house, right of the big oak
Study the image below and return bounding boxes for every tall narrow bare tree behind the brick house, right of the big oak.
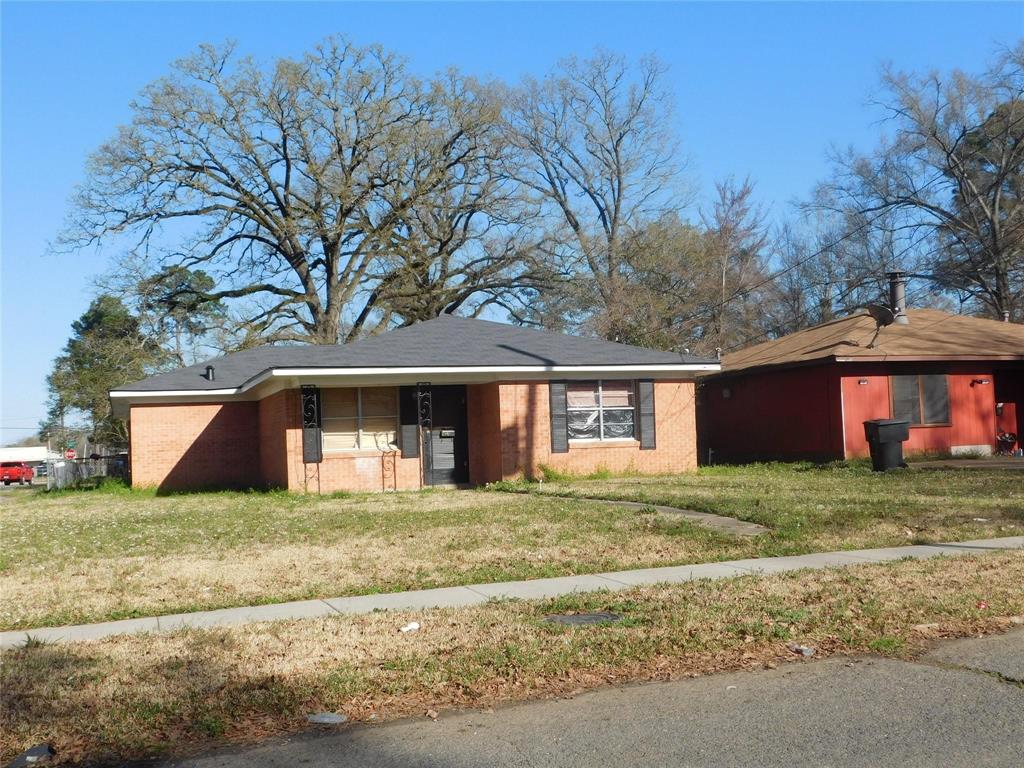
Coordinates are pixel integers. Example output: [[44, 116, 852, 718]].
[[506, 52, 680, 339]]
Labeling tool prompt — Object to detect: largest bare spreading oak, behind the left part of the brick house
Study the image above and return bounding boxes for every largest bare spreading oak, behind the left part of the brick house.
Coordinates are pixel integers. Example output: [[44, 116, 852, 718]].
[[61, 39, 527, 343]]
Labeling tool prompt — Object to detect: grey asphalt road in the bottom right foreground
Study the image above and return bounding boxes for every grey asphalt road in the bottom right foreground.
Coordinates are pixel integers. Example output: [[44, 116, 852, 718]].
[[173, 630, 1024, 768]]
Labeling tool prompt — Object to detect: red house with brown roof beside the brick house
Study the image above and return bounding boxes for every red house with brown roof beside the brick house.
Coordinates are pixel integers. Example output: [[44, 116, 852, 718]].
[[698, 309, 1024, 463]]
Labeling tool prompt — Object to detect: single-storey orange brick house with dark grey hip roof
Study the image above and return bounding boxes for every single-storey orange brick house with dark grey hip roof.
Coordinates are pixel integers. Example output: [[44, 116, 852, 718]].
[[111, 315, 719, 493]]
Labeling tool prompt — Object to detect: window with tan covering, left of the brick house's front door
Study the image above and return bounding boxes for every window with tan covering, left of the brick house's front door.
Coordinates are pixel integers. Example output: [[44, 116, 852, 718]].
[[322, 387, 398, 451]]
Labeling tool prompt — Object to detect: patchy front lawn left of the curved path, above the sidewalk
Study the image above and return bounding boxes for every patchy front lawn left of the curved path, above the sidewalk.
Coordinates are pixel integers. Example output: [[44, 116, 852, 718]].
[[0, 492, 753, 629]]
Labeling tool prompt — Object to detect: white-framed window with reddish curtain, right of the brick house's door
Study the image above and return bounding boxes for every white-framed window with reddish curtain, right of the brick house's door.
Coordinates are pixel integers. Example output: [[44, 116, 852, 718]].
[[565, 381, 636, 440]]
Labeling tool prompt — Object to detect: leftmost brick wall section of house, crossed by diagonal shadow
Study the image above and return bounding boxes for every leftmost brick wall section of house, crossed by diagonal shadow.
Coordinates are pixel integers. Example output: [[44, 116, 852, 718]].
[[130, 402, 263, 490]]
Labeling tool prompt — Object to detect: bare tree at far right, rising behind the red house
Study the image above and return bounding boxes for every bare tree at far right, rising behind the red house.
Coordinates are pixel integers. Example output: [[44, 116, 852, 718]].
[[821, 42, 1024, 321]]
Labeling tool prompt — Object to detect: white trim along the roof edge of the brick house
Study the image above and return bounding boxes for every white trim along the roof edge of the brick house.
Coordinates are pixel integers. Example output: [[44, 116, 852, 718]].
[[110, 362, 722, 399]]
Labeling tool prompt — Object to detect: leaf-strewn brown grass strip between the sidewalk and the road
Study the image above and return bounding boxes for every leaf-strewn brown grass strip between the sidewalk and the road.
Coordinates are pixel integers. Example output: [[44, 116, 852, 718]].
[[0, 552, 1024, 760]]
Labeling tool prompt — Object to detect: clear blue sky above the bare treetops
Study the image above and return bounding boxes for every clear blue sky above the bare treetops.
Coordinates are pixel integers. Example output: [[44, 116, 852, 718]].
[[0, 1, 1024, 442]]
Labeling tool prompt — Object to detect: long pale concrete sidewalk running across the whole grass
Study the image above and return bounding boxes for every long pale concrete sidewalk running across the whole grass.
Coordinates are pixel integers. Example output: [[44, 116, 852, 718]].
[[0, 536, 1024, 648]]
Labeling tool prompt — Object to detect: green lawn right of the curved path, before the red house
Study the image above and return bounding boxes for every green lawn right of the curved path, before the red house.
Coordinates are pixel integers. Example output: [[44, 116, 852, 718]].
[[508, 463, 1024, 557]]
